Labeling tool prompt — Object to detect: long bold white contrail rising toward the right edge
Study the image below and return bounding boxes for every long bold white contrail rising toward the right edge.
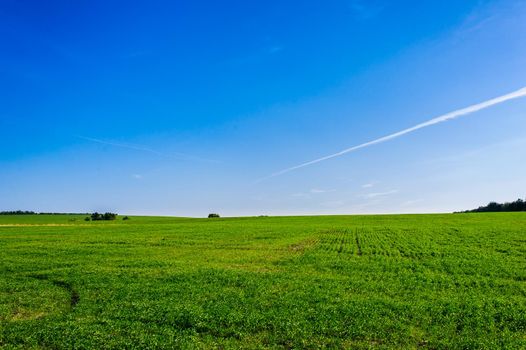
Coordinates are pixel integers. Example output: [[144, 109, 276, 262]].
[[261, 87, 526, 180]]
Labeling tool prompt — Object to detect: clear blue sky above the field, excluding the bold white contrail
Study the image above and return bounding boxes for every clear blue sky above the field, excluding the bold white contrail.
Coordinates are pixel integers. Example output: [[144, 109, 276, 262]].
[[0, 0, 526, 216]]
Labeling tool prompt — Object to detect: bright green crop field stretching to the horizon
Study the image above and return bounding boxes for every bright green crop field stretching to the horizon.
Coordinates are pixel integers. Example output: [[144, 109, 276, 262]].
[[0, 213, 526, 349]]
